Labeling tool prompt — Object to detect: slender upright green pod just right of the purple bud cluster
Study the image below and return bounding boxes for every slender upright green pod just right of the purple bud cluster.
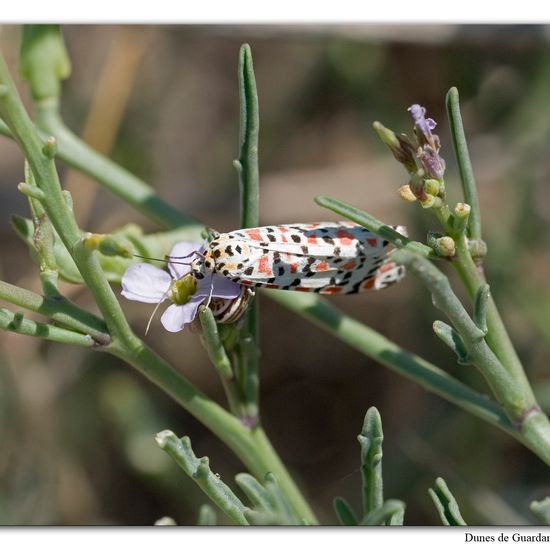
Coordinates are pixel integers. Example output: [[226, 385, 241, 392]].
[[445, 87, 481, 239]]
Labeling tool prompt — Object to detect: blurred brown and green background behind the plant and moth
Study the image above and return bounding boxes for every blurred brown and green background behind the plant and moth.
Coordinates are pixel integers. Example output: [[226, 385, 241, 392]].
[[0, 25, 550, 525]]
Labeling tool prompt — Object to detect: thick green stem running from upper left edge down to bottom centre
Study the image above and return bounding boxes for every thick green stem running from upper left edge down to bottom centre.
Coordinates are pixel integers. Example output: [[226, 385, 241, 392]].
[[0, 50, 316, 523]]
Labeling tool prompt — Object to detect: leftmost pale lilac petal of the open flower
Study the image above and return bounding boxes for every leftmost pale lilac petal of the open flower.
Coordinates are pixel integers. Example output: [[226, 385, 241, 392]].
[[121, 263, 172, 304]]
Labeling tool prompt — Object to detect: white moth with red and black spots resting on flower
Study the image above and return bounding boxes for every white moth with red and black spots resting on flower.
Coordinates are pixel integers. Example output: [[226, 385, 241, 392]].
[[191, 221, 406, 299]]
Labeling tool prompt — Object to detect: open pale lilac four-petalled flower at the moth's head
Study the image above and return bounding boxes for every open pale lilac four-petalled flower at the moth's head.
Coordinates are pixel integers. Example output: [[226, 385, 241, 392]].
[[122, 242, 240, 332]]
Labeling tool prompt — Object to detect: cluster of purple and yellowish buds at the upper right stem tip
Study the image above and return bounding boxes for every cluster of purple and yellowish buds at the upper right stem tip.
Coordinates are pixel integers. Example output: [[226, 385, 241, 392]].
[[374, 104, 445, 208]]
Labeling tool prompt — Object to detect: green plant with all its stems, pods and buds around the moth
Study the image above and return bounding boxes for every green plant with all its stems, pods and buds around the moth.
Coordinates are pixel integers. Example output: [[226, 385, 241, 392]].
[[0, 25, 550, 525]]
